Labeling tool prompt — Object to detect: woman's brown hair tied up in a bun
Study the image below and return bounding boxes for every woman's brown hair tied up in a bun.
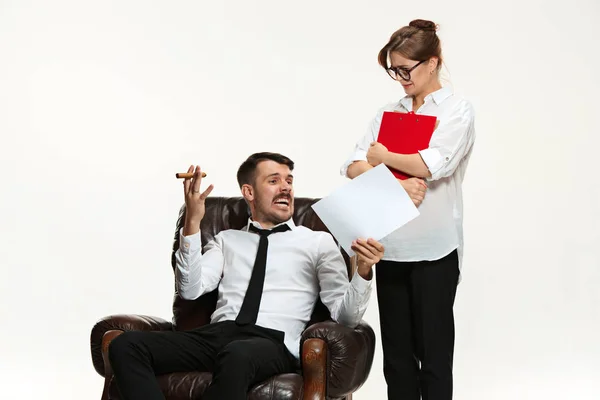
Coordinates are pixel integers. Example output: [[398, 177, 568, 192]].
[[377, 19, 442, 71]]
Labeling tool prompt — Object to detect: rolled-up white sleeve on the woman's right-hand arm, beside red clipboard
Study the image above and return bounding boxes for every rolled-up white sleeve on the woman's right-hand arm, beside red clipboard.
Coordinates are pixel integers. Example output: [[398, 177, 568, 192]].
[[419, 100, 475, 181]]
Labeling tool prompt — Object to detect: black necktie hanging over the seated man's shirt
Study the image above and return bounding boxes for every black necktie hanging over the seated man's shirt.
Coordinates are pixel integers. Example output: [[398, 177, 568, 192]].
[[235, 224, 290, 325]]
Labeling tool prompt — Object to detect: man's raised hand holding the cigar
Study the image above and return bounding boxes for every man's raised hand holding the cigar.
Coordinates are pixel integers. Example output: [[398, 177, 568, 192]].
[[183, 165, 213, 236]]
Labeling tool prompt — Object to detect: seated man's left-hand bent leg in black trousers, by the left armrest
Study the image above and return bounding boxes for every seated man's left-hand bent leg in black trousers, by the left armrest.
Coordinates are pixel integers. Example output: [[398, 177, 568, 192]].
[[108, 324, 227, 400]]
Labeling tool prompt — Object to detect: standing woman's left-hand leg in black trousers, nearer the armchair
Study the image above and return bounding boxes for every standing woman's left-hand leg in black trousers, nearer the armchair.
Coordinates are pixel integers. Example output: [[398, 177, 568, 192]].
[[375, 261, 421, 400]]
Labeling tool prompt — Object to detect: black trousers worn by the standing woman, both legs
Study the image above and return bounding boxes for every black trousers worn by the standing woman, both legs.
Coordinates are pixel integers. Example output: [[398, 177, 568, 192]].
[[375, 250, 459, 400]]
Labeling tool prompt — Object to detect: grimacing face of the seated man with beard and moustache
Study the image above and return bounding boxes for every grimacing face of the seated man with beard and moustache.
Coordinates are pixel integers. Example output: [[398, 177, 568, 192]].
[[244, 160, 294, 228]]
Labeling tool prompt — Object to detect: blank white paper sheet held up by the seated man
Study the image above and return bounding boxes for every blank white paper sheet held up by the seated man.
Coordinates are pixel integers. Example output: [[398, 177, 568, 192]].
[[312, 164, 419, 256]]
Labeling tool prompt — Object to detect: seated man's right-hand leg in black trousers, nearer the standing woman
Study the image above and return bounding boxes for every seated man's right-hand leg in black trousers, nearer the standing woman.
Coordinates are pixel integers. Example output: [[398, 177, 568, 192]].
[[202, 337, 295, 400]]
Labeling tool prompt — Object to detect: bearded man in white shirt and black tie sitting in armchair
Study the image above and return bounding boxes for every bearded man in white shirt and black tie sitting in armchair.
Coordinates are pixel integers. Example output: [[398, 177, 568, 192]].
[[109, 153, 383, 400]]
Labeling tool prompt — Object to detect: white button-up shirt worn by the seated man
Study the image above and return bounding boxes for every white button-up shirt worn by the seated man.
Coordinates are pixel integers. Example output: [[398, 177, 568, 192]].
[[175, 220, 371, 358]]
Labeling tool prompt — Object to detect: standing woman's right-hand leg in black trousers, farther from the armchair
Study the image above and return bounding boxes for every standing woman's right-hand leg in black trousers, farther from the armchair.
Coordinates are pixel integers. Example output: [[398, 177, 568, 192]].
[[412, 251, 459, 400]]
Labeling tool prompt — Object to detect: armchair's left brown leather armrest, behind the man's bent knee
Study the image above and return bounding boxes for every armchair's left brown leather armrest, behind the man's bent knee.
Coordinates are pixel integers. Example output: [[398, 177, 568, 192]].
[[90, 314, 173, 376]]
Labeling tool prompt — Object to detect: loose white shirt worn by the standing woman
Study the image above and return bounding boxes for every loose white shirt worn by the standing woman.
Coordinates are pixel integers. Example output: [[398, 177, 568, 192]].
[[340, 88, 475, 266]]
